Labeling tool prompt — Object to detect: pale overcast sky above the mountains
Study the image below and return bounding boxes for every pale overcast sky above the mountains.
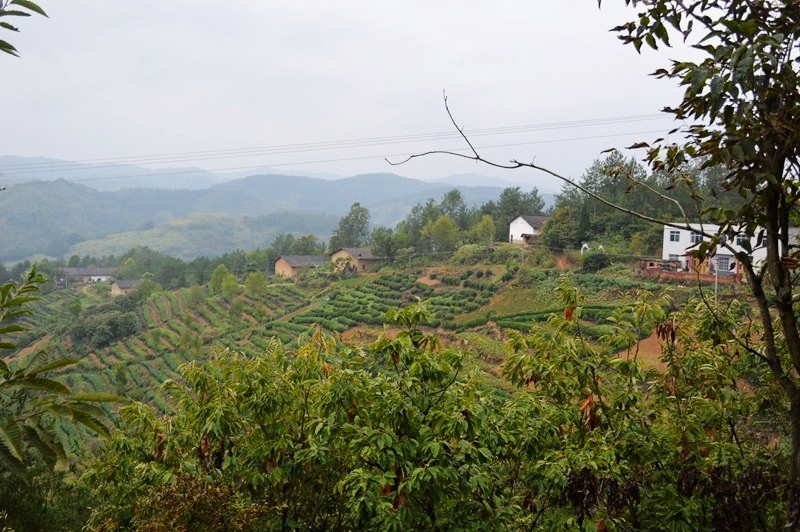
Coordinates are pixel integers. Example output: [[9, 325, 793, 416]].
[[0, 0, 681, 191]]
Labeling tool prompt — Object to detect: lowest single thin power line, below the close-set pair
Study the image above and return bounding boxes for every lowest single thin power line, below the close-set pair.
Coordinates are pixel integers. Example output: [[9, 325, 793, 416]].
[[17, 129, 663, 182]]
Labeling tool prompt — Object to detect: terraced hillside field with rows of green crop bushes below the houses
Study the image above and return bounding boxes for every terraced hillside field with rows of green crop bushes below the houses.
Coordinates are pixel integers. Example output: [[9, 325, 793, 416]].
[[9, 269, 668, 432]]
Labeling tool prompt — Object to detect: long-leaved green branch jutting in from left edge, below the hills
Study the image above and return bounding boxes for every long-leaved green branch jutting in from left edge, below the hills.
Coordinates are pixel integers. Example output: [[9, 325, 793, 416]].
[[0, 267, 122, 478]]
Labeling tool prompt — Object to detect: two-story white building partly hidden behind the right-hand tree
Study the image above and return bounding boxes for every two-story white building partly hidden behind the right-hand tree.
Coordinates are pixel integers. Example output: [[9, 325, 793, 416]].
[[661, 224, 767, 275]]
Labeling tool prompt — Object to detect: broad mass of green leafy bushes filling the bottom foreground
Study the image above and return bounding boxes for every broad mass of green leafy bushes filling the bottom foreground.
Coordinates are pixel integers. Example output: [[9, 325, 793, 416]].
[[86, 277, 782, 530]]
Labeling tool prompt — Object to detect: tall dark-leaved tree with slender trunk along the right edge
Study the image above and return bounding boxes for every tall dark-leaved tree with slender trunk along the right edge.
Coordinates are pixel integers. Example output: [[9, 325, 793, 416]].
[[600, 0, 800, 528]]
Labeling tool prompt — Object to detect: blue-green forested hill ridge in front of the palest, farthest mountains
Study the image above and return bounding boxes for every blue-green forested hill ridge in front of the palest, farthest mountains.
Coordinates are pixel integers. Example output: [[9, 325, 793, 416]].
[[0, 174, 532, 261]]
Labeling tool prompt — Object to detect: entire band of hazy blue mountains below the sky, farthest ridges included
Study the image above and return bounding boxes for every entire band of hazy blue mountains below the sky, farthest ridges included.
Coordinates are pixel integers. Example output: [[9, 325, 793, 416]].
[[0, 156, 553, 262]]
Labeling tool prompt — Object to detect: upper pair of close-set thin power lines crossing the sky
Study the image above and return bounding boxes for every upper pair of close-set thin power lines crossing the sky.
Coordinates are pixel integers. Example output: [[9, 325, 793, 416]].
[[0, 114, 671, 175]]
